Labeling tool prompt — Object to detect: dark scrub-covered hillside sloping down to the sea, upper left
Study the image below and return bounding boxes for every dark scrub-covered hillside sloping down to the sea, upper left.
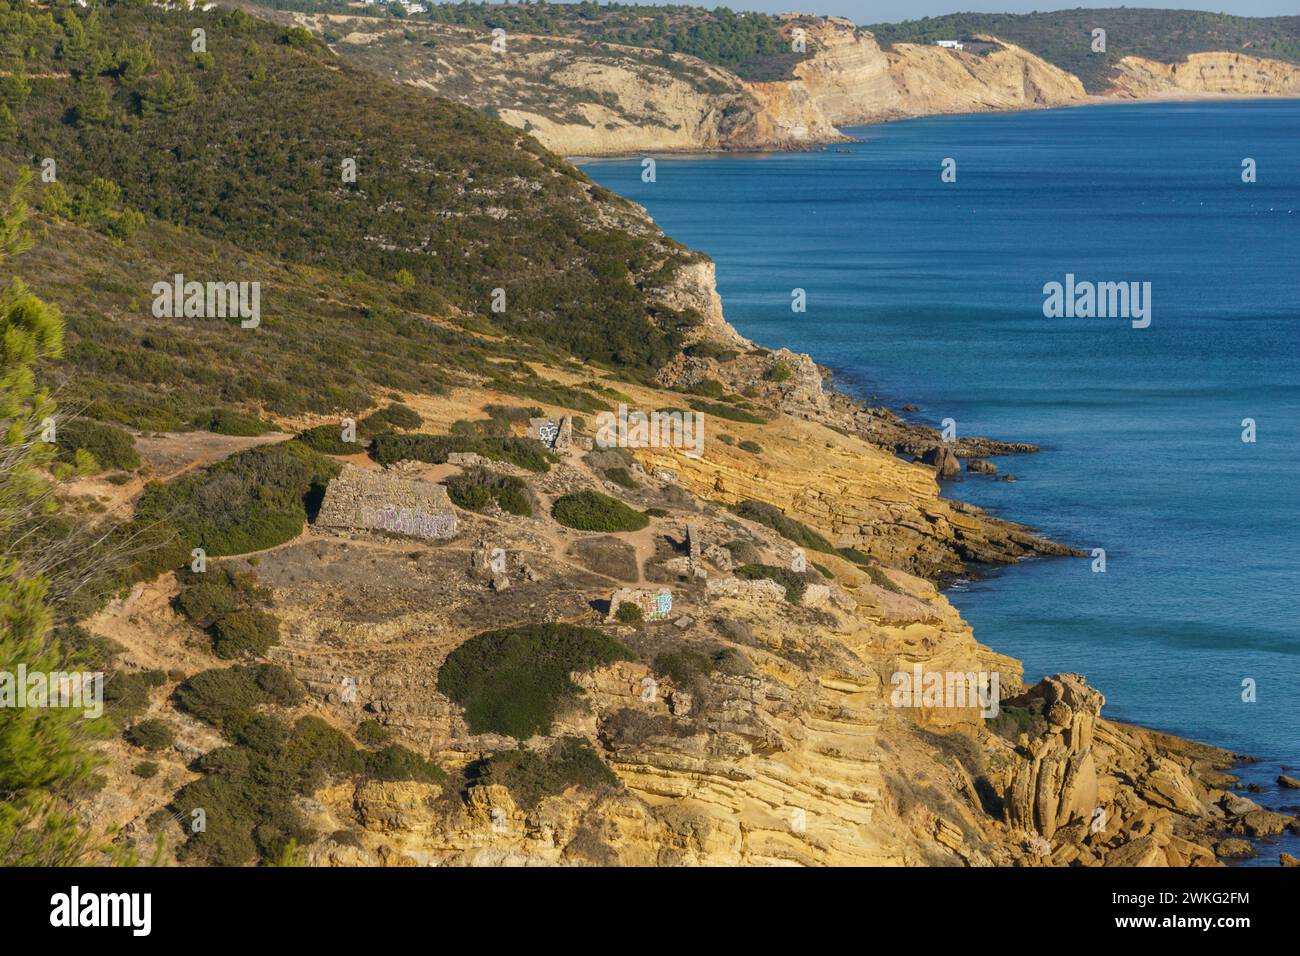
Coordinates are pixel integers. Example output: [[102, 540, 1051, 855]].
[[0, 0, 712, 424]]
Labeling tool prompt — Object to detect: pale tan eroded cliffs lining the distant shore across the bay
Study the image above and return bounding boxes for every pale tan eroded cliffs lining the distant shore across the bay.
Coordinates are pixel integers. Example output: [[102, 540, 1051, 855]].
[[271, 10, 1300, 156]]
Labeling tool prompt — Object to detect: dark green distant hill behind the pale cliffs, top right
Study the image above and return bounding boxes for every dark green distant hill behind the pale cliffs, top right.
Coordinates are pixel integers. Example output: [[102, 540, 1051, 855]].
[[866, 8, 1300, 94]]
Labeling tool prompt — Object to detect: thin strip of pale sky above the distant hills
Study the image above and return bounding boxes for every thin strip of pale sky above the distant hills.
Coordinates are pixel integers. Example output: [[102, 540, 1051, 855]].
[[613, 0, 1300, 23]]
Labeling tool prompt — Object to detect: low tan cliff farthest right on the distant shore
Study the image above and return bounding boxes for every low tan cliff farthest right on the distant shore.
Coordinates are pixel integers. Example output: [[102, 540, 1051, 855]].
[[1112, 53, 1300, 98]]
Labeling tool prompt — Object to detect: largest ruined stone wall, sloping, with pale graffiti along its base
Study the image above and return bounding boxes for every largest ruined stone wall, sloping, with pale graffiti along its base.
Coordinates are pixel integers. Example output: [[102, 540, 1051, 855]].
[[316, 466, 456, 538]]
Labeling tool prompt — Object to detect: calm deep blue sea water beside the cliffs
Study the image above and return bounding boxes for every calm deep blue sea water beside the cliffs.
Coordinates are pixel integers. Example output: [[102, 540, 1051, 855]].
[[584, 101, 1300, 862]]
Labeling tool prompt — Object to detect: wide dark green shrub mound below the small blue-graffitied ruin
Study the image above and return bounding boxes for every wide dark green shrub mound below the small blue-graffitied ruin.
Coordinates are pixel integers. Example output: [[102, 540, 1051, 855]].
[[438, 624, 632, 740]]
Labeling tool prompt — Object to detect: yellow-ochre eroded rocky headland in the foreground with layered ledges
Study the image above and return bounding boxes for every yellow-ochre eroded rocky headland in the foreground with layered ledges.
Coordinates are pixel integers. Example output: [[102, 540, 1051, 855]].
[[73, 244, 1297, 866]]
